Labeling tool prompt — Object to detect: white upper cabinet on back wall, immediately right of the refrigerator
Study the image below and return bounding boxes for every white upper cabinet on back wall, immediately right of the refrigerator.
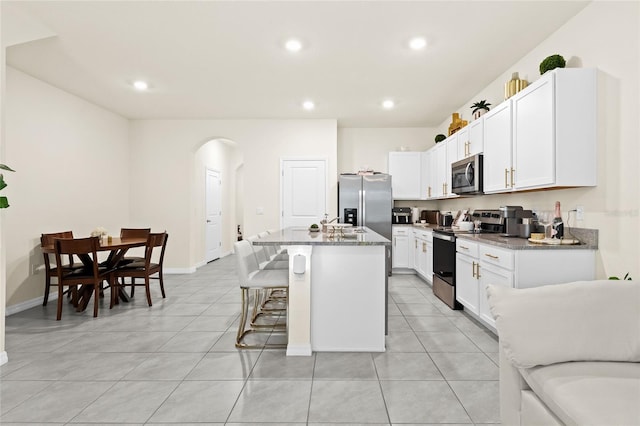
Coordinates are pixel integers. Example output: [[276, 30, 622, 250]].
[[389, 152, 424, 200]]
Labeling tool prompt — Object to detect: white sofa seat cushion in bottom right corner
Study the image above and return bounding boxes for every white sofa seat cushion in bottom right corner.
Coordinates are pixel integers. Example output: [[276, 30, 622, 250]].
[[521, 362, 640, 425]]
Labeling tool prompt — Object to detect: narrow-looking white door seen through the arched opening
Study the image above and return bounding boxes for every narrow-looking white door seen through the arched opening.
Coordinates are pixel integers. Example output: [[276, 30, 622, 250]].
[[205, 169, 222, 262]]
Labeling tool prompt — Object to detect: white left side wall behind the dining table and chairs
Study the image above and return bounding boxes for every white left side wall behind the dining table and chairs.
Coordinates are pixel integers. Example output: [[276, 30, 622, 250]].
[[2, 67, 132, 306]]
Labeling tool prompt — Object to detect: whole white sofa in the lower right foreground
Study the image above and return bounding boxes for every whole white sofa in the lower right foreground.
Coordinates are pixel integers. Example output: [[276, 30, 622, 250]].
[[487, 280, 640, 426]]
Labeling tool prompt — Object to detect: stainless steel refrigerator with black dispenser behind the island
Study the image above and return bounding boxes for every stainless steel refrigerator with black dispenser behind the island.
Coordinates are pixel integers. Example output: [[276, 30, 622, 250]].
[[338, 173, 392, 330]]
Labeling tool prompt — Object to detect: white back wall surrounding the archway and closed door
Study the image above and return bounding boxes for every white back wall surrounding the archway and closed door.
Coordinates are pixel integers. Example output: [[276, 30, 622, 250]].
[[129, 120, 337, 271]]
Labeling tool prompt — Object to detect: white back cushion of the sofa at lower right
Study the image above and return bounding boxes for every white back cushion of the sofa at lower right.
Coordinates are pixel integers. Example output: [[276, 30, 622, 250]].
[[487, 280, 640, 368]]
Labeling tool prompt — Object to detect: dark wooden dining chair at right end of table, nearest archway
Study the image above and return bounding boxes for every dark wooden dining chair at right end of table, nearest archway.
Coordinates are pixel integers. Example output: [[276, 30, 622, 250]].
[[114, 232, 169, 306]]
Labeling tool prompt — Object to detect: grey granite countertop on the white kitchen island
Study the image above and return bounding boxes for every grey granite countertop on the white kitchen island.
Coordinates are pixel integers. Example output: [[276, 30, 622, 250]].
[[253, 227, 391, 246]]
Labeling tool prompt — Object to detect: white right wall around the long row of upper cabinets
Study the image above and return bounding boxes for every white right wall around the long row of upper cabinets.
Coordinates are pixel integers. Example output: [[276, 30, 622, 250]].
[[438, 2, 640, 280]]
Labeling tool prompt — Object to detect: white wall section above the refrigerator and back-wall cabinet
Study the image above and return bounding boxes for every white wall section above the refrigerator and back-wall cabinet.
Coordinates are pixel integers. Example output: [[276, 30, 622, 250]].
[[338, 127, 438, 173]]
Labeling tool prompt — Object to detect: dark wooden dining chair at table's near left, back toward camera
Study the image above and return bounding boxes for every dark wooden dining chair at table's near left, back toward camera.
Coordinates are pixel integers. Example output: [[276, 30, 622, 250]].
[[54, 237, 112, 321]]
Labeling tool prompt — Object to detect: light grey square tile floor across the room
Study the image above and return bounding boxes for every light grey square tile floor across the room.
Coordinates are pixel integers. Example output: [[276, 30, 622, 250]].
[[0, 256, 499, 426]]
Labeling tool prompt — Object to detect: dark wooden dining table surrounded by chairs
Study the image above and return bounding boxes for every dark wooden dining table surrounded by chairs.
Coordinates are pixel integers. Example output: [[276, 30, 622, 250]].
[[42, 237, 147, 311]]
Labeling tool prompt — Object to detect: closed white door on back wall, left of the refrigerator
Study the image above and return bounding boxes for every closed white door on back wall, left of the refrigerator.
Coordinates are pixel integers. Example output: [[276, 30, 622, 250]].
[[280, 160, 327, 228]]
